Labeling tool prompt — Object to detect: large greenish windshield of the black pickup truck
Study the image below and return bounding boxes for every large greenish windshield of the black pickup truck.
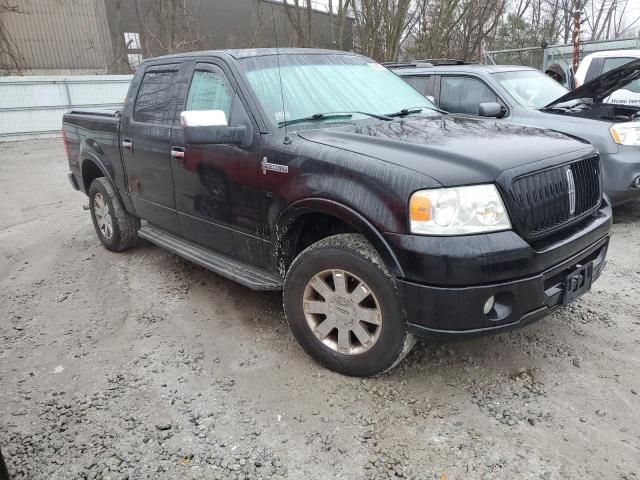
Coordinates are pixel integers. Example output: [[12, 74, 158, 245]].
[[241, 54, 436, 128]]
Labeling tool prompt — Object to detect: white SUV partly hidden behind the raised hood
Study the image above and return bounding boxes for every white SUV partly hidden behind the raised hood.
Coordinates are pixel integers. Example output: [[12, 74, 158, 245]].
[[575, 50, 640, 105]]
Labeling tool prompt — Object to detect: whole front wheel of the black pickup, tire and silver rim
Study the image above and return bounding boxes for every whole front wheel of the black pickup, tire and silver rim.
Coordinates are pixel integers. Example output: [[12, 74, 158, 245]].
[[284, 234, 415, 377]]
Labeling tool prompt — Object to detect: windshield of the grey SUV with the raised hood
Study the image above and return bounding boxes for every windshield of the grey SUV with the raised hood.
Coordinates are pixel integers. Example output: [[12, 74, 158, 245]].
[[493, 70, 569, 110]]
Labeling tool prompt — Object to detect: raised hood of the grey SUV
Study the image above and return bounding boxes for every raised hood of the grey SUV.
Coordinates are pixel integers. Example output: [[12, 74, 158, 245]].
[[541, 59, 640, 111]]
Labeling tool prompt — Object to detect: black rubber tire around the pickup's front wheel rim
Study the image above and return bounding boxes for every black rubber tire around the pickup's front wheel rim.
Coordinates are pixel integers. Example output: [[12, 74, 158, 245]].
[[283, 234, 415, 377]]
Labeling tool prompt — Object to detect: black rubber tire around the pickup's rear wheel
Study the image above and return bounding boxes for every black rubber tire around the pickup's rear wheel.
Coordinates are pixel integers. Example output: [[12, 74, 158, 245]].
[[89, 177, 140, 252]]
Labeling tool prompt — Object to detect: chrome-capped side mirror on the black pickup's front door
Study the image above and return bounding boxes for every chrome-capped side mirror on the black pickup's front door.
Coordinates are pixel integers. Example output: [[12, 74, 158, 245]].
[[180, 110, 247, 145]]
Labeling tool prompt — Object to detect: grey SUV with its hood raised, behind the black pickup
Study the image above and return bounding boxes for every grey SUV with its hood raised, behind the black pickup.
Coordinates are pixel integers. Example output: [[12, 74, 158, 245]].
[[389, 60, 640, 205]]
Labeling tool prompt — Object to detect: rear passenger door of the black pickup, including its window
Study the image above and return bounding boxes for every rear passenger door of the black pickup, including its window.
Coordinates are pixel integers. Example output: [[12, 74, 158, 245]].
[[121, 64, 180, 232]]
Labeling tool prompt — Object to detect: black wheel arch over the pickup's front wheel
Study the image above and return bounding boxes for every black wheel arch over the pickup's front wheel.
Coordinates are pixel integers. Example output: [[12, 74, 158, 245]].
[[273, 198, 403, 277]]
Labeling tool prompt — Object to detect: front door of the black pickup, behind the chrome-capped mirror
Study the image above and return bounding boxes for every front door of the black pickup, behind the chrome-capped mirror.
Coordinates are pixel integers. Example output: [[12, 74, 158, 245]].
[[172, 63, 265, 265]]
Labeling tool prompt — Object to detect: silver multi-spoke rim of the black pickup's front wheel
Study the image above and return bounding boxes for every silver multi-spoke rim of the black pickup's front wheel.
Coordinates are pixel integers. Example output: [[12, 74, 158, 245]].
[[303, 270, 382, 355]]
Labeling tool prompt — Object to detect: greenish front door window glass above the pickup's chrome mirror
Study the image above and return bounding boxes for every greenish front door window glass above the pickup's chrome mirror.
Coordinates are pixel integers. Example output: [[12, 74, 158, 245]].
[[185, 67, 231, 118]]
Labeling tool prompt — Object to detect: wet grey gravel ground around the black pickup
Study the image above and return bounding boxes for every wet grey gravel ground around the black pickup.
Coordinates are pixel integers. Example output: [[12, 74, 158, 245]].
[[0, 140, 640, 480]]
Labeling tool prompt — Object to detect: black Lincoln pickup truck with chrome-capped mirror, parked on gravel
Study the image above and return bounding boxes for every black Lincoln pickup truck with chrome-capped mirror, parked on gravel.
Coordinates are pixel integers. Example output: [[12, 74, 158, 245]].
[[63, 49, 611, 376]]
